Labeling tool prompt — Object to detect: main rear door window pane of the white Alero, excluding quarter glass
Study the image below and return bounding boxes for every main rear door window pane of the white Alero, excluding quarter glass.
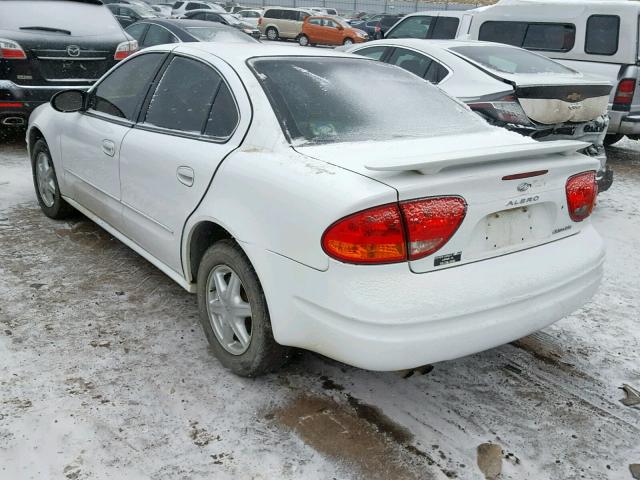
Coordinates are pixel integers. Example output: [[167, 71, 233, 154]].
[[144, 57, 222, 134]]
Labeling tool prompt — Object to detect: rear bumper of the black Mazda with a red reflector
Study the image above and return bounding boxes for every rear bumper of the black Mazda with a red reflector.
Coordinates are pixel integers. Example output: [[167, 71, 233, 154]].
[[0, 80, 89, 126]]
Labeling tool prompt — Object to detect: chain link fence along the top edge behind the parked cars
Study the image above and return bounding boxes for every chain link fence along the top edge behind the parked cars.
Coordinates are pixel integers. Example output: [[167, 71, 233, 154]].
[[235, 0, 481, 16]]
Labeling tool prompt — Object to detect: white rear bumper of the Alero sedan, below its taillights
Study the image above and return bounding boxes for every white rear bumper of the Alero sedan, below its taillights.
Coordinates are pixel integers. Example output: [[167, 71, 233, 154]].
[[243, 225, 604, 370]]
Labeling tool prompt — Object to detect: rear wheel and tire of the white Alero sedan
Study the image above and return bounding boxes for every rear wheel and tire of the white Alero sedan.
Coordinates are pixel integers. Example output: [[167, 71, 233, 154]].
[[198, 240, 291, 377]]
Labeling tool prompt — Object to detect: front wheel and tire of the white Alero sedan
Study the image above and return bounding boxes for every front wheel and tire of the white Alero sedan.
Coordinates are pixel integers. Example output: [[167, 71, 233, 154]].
[[31, 138, 75, 220]]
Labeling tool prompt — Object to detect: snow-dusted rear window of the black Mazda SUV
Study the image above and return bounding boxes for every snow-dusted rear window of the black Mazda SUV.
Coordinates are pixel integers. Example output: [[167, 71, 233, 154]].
[[0, 0, 122, 36]]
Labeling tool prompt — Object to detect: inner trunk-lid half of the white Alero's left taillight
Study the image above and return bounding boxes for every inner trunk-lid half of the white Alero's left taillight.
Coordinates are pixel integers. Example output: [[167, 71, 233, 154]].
[[400, 197, 467, 260]]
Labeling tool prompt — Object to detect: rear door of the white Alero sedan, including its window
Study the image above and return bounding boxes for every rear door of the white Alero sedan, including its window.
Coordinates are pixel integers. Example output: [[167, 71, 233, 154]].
[[120, 55, 251, 274]]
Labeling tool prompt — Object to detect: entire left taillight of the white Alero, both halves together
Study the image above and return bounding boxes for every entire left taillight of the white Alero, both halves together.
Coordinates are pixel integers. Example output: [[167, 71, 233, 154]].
[[322, 197, 466, 264]]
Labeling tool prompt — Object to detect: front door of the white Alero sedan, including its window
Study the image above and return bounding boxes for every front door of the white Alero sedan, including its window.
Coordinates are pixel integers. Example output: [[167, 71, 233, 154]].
[[60, 53, 165, 227]]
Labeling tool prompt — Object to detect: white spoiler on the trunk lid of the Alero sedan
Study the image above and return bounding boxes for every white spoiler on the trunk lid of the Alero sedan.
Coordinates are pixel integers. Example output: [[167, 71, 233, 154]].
[[365, 140, 590, 175]]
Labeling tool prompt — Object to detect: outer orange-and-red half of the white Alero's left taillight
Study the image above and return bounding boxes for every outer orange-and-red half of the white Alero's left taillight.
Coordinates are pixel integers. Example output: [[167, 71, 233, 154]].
[[322, 203, 407, 263]]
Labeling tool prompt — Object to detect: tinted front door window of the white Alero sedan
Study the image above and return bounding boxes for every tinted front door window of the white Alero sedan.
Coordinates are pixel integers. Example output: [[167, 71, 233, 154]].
[[89, 53, 164, 121]]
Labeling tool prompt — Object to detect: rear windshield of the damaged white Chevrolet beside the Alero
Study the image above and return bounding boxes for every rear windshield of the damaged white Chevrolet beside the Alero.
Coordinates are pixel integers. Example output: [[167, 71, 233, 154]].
[[450, 45, 577, 75]]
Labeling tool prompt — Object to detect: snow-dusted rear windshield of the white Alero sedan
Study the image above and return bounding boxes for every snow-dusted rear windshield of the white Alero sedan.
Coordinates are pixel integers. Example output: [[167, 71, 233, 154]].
[[250, 57, 491, 143]]
